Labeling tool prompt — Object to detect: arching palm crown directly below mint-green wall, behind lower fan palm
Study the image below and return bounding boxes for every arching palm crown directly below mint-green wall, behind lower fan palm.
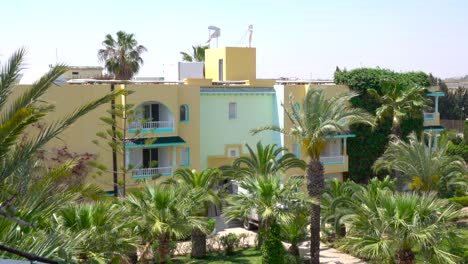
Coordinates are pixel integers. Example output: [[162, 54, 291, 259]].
[[221, 142, 305, 179]]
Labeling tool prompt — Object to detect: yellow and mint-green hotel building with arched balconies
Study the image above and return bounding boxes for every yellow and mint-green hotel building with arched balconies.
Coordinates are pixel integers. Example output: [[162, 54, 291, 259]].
[[15, 47, 442, 193]]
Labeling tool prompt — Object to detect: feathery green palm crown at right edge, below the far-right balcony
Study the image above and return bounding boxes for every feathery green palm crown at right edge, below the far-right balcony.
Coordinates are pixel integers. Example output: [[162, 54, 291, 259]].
[[374, 133, 468, 196]]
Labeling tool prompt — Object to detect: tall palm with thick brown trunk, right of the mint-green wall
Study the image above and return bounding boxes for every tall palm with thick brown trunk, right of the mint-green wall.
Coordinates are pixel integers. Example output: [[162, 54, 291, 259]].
[[253, 89, 373, 263]]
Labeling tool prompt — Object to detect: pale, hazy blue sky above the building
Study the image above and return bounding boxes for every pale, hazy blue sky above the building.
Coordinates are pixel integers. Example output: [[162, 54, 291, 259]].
[[0, 0, 468, 82]]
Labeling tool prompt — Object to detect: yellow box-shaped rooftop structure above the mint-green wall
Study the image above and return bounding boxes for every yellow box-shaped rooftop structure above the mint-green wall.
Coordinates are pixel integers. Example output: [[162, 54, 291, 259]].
[[205, 47, 257, 81]]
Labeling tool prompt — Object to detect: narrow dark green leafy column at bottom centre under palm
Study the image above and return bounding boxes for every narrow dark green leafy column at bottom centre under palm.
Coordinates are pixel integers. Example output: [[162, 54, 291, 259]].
[[262, 223, 285, 264]]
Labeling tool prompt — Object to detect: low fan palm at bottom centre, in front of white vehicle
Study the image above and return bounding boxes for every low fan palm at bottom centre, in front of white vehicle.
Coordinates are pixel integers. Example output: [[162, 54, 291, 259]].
[[223, 174, 311, 262]]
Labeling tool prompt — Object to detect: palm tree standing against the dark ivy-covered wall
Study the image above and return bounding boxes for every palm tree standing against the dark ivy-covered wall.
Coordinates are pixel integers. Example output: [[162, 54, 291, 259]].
[[367, 80, 430, 138]]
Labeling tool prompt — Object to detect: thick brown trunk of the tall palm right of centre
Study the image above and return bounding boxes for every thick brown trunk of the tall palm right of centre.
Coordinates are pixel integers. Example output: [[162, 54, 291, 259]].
[[307, 159, 325, 264]]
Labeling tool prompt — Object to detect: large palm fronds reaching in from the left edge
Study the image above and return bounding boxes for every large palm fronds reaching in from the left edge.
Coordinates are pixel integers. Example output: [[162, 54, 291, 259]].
[[0, 49, 120, 262]]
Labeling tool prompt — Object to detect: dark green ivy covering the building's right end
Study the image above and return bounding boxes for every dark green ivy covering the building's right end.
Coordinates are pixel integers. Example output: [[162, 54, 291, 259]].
[[334, 68, 431, 182]]
